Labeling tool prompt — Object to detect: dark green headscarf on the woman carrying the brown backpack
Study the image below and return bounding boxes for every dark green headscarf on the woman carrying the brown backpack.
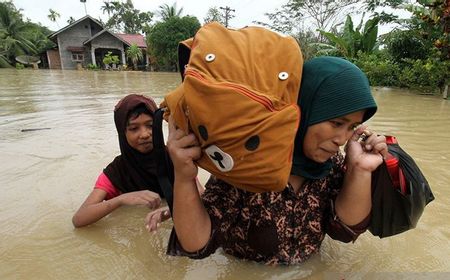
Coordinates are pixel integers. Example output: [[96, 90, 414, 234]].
[[291, 57, 377, 179]]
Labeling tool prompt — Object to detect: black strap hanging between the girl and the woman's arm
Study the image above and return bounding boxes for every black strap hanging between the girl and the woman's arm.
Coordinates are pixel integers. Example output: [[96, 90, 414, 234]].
[[152, 108, 174, 213]]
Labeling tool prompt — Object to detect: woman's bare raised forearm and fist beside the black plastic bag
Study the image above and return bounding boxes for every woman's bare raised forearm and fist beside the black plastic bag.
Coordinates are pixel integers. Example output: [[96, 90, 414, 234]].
[[335, 126, 388, 226]]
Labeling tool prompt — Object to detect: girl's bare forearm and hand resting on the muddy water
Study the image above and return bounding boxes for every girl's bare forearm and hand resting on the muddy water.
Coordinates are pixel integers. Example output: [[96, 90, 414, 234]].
[[72, 189, 161, 228]]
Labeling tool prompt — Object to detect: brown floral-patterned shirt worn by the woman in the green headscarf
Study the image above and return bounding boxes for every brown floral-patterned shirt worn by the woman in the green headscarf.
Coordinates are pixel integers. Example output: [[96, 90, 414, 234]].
[[168, 154, 369, 264]]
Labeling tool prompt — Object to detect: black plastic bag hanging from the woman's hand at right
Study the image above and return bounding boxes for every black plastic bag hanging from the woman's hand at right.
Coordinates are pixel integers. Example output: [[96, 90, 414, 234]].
[[369, 139, 434, 238]]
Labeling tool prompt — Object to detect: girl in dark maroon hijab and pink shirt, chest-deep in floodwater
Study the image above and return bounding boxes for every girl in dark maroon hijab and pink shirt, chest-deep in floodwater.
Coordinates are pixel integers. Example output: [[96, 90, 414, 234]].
[[72, 94, 170, 227]]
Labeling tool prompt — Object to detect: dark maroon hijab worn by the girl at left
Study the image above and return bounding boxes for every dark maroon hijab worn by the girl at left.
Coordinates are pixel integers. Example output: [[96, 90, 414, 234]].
[[103, 94, 162, 197]]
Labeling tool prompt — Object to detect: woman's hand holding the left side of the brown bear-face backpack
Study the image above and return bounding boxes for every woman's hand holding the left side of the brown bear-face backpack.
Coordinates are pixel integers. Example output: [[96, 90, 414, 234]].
[[167, 116, 201, 182]]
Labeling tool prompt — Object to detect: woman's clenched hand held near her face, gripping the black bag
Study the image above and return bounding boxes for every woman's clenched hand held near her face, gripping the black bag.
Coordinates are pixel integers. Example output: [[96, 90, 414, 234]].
[[345, 125, 388, 172]]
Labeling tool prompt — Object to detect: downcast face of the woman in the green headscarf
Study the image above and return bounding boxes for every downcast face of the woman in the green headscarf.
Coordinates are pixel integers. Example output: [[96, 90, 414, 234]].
[[303, 110, 365, 163]]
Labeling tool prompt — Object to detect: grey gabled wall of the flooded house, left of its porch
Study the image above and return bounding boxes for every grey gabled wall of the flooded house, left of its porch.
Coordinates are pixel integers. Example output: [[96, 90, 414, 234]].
[[58, 18, 102, 69]]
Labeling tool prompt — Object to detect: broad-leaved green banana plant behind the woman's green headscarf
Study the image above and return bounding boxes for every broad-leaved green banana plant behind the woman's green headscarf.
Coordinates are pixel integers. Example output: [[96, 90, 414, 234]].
[[318, 16, 380, 58]]
